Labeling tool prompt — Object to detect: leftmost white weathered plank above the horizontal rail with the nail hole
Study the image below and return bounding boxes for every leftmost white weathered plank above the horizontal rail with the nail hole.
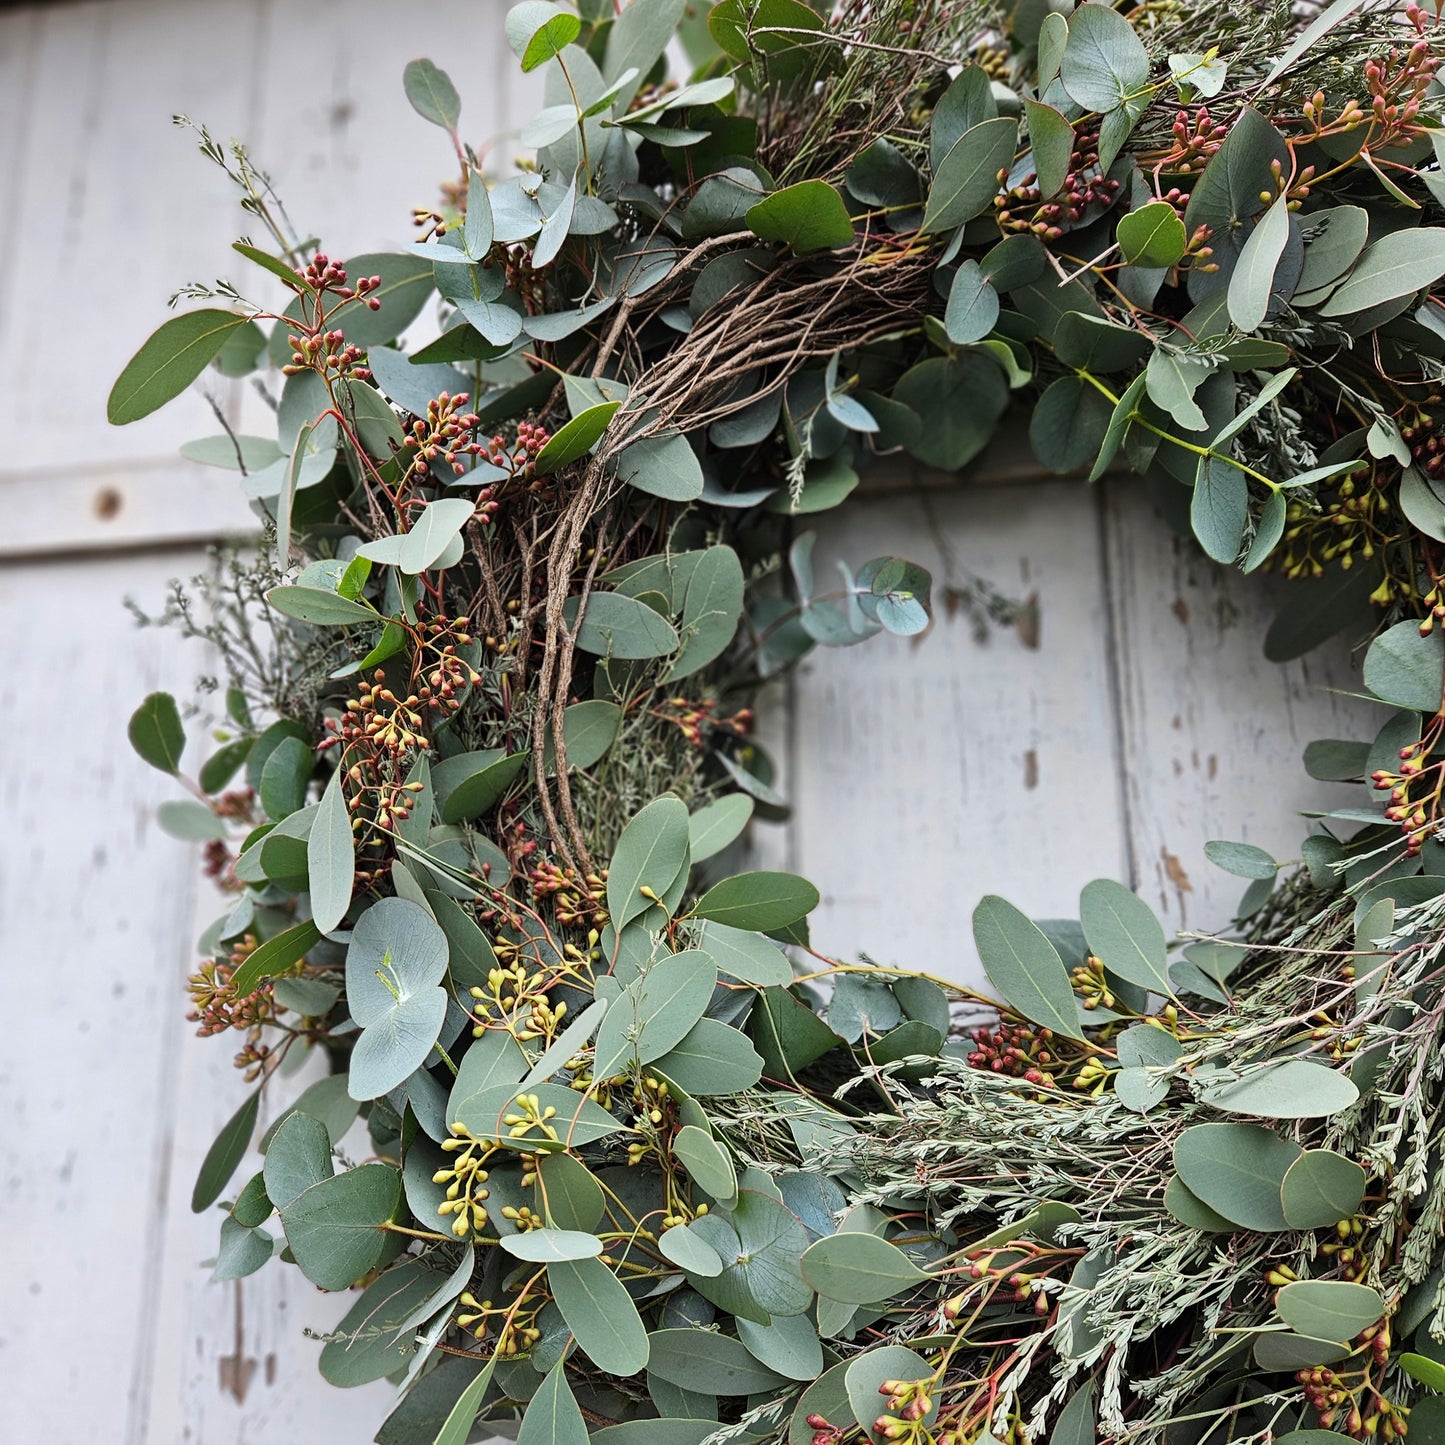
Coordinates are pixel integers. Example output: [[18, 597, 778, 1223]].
[[0, 0, 263, 471]]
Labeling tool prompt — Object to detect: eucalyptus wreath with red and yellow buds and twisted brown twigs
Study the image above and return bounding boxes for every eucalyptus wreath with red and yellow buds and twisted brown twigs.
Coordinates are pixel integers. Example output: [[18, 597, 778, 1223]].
[[110, 0, 1445, 1445]]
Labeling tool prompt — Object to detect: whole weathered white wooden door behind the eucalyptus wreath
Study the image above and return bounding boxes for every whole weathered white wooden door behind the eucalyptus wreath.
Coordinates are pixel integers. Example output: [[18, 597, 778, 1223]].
[[0, 0, 1368, 1445]]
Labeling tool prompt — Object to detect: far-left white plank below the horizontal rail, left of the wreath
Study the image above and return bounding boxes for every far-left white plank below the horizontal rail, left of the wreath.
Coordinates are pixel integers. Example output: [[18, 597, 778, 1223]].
[[0, 556, 204, 1441]]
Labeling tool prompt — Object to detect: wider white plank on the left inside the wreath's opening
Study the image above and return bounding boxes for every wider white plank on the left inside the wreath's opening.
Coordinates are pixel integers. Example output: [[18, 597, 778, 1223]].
[[790, 483, 1126, 985]]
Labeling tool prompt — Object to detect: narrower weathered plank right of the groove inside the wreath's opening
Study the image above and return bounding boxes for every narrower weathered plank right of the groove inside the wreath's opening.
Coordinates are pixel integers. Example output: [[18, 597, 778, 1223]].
[[1105, 477, 1383, 931]]
